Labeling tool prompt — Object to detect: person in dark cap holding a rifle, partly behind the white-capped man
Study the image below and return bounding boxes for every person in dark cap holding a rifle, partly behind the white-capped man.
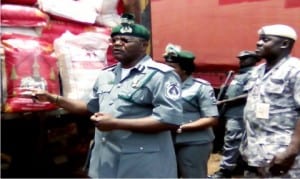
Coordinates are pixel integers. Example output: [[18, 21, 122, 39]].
[[209, 50, 259, 178]]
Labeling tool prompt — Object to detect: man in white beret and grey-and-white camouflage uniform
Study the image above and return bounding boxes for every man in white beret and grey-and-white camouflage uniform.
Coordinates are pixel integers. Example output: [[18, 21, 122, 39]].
[[240, 24, 300, 178]]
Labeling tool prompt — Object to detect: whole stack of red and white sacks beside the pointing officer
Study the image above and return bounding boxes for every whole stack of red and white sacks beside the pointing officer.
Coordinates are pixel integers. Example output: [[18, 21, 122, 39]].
[[1, 0, 124, 113]]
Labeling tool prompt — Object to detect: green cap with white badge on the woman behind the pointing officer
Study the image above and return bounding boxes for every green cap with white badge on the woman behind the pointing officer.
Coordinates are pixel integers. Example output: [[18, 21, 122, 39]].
[[163, 44, 195, 63]]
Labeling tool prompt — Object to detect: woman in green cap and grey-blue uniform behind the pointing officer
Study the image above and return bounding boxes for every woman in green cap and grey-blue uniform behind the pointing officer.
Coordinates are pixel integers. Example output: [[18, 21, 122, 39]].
[[163, 44, 218, 178]]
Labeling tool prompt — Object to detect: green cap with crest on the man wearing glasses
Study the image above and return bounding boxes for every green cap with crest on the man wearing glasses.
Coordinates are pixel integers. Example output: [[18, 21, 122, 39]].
[[111, 14, 150, 40]]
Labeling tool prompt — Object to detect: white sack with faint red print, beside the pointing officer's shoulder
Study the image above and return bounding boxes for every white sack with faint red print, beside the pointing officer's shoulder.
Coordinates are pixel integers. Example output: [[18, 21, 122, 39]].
[[54, 32, 110, 100]]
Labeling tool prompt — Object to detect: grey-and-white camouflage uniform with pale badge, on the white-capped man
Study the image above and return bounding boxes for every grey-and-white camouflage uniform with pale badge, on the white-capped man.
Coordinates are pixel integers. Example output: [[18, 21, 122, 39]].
[[240, 57, 300, 177]]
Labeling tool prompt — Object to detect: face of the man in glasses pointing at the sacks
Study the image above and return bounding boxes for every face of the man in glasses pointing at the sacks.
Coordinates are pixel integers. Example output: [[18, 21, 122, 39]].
[[111, 35, 148, 68]]
